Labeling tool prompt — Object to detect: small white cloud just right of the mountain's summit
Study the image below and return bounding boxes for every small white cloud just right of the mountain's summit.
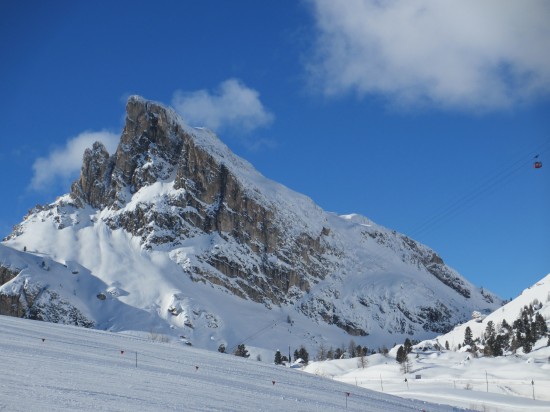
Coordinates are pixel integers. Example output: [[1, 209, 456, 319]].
[[172, 79, 273, 133]]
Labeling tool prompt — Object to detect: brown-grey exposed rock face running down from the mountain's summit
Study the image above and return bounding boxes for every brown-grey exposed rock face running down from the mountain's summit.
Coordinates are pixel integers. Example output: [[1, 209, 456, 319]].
[[71, 98, 331, 304]]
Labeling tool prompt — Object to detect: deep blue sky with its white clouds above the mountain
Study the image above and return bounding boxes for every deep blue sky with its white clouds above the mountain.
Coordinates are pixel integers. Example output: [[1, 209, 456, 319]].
[[0, 0, 550, 298]]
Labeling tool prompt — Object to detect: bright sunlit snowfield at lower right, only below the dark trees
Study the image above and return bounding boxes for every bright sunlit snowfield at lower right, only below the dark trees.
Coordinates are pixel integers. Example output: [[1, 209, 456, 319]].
[[305, 339, 550, 412]]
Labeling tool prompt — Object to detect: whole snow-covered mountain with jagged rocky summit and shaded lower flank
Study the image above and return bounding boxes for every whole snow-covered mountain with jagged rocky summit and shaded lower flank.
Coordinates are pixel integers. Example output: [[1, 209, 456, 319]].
[[0, 96, 501, 349]]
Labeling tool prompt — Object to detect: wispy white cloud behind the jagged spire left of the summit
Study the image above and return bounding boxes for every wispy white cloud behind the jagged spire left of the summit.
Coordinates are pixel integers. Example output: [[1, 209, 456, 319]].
[[30, 131, 120, 191]]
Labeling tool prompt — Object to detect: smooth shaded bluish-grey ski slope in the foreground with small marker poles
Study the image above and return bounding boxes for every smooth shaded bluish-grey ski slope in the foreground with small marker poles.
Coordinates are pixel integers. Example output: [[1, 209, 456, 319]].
[[0, 316, 464, 412]]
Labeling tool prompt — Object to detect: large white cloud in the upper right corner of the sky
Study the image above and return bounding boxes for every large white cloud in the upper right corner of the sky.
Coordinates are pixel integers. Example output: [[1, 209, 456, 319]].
[[308, 0, 550, 110]]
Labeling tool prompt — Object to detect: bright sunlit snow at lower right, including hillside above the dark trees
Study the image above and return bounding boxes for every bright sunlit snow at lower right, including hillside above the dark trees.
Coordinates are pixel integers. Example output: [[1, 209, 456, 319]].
[[305, 274, 550, 412]]
